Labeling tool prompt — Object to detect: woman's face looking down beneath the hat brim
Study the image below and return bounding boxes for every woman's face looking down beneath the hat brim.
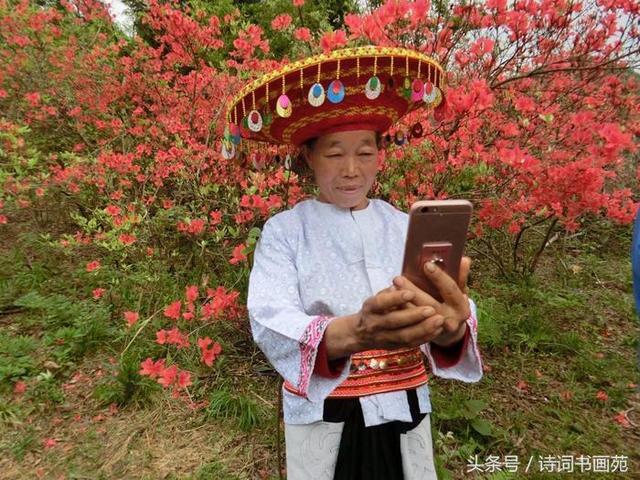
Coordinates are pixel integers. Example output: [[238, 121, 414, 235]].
[[305, 130, 378, 210]]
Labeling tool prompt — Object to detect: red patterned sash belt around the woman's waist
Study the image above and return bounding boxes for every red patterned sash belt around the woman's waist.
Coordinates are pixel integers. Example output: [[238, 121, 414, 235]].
[[284, 347, 428, 398]]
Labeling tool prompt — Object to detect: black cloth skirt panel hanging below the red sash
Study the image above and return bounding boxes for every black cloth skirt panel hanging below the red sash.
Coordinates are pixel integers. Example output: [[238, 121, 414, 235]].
[[323, 389, 426, 480]]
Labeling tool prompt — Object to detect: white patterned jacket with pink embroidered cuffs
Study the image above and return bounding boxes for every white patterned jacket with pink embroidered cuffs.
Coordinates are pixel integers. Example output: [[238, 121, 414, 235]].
[[247, 199, 482, 426]]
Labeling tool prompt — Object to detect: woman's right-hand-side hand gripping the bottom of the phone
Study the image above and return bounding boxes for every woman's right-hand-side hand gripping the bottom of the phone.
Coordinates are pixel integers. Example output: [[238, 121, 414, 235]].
[[393, 257, 471, 346]]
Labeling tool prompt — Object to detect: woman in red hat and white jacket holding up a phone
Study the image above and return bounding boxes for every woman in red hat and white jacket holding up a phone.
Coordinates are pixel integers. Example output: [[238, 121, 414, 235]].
[[225, 47, 482, 480]]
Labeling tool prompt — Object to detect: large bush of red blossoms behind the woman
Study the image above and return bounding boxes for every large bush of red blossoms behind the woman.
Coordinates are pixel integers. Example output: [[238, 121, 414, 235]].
[[0, 0, 640, 404]]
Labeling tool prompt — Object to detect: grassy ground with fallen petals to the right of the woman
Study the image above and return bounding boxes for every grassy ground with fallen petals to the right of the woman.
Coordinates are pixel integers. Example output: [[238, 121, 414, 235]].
[[424, 227, 640, 478]]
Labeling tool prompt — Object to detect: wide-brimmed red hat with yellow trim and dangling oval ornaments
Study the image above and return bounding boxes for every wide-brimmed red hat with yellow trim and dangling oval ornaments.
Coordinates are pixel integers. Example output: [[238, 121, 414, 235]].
[[223, 46, 445, 156]]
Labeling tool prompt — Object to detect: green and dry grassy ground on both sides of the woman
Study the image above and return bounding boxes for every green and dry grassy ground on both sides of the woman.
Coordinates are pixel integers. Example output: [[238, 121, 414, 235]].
[[0, 219, 640, 480]]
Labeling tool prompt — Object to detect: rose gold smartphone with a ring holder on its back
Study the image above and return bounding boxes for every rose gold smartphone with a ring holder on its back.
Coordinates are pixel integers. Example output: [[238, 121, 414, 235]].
[[402, 200, 473, 301]]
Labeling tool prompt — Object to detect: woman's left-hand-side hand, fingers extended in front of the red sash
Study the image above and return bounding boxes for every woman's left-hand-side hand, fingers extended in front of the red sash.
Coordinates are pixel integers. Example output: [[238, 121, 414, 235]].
[[324, 288, 444, 360]]
